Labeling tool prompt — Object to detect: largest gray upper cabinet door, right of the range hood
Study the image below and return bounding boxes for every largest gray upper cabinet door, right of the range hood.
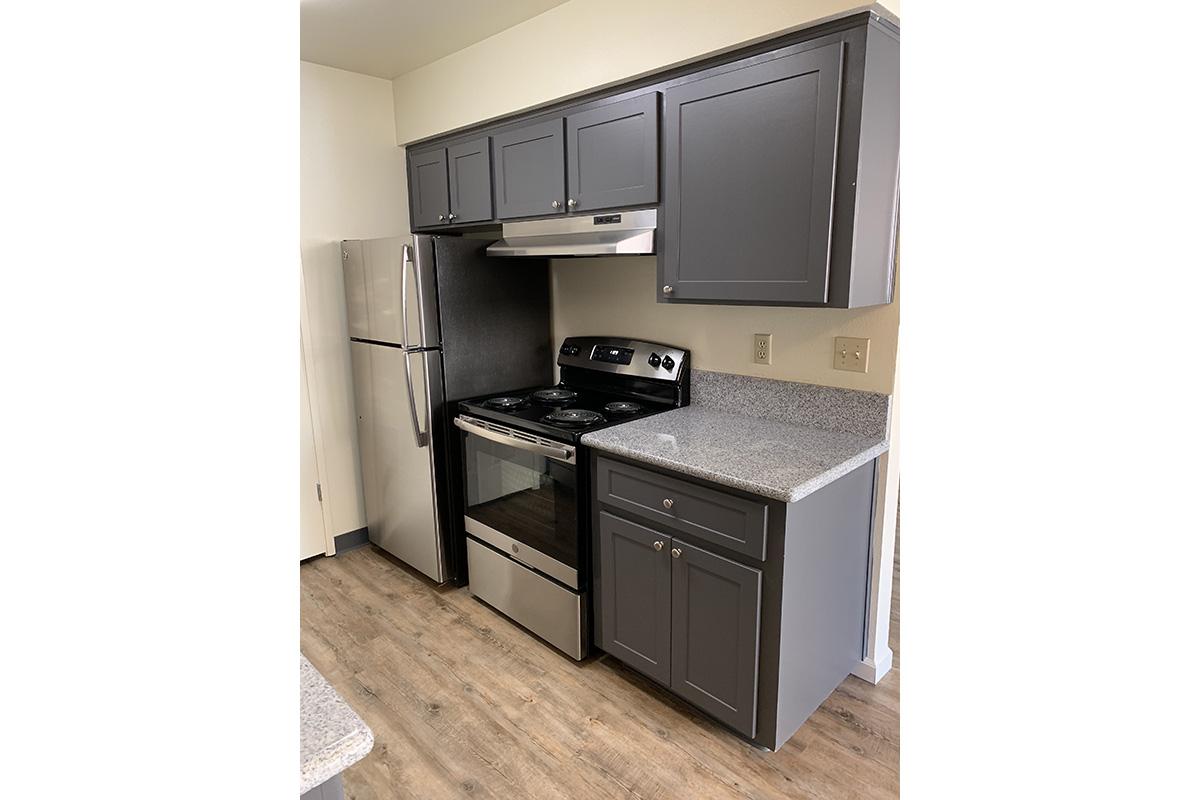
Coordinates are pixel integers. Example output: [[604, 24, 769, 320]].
[[660, 42, 844, 303]]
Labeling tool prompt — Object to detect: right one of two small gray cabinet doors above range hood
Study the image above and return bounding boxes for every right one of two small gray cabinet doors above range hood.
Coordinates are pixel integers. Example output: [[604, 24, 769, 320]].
[[566, 91, 659, 211]]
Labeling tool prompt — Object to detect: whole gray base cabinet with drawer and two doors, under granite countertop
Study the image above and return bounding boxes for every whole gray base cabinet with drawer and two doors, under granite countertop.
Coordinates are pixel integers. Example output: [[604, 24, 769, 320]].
[[592, 453, 876, 750]]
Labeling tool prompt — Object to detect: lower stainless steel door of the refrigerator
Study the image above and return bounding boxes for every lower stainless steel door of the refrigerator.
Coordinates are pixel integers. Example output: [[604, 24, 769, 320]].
[[361, 344, 445, 583]]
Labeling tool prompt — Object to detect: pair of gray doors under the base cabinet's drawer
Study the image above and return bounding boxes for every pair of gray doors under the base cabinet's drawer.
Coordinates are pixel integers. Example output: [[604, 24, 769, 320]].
[[598, 512, 762, 736]]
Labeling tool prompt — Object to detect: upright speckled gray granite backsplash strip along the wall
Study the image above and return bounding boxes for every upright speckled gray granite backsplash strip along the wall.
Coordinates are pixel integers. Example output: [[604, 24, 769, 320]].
[[691, 369, 892, 439]]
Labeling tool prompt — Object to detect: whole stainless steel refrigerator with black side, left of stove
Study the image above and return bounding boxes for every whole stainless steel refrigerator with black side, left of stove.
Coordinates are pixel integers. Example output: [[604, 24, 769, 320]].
[[342, 234, 553, 583]]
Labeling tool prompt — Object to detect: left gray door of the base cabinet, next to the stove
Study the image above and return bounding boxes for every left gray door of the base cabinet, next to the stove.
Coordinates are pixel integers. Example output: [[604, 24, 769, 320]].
[[598, 511, 671, 685]]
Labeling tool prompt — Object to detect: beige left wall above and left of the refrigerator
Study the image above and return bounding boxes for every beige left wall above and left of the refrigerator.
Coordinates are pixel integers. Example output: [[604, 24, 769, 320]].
[[300, 61, 408, 536]]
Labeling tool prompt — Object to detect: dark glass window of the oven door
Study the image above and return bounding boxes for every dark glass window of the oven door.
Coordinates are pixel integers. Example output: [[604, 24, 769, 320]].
[[463, 433, 580, 571]]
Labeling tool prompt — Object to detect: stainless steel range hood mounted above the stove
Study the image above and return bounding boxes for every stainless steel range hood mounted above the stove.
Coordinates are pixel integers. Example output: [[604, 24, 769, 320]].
[[487, 209, 659, 257]]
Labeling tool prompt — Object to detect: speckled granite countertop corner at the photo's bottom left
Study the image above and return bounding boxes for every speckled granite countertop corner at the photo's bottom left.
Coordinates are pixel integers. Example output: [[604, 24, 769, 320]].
[[300, 655, 374, 794]]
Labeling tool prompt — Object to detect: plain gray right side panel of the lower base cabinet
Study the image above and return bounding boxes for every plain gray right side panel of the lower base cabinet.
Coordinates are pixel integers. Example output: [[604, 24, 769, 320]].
[[775, 461, 875, 748]]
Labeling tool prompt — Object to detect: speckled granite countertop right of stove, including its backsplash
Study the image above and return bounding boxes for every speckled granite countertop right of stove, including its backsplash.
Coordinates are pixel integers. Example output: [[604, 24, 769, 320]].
[[582, 369, 892, 503]]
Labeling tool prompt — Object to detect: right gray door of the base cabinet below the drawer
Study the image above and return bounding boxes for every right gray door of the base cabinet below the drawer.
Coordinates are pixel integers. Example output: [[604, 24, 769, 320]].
[[671, 539, 762, 736]]
